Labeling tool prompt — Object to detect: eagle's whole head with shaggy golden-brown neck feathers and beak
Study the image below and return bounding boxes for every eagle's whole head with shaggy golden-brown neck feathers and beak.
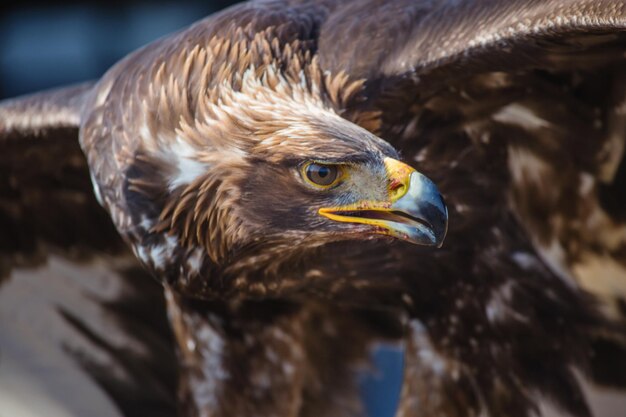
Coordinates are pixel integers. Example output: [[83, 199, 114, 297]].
[[89, 41, 447, 295]]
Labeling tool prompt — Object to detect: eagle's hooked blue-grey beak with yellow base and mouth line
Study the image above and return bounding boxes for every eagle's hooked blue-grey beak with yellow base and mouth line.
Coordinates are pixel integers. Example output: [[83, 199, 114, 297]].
[[319, 158, 448, 247]]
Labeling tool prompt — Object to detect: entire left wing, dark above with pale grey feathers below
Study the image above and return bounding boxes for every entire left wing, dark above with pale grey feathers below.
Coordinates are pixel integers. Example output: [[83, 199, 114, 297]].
[[0, 84, 175, 416]]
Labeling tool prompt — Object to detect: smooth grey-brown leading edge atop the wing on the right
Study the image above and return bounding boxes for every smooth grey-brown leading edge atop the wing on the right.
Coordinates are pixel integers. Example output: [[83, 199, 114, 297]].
[[319, 0, 626, 80]]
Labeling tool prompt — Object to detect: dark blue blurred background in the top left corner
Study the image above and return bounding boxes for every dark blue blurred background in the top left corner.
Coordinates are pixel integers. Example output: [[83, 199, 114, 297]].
[[0, 0, 237, 99]]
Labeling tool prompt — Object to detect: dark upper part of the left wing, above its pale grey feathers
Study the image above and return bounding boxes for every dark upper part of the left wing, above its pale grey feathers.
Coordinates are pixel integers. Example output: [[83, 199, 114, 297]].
[[0, 84, 121, 276]]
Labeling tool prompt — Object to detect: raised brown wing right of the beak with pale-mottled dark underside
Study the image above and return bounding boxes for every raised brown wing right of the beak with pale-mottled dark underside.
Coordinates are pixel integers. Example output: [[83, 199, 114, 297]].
[[319, 0, 626, 307]]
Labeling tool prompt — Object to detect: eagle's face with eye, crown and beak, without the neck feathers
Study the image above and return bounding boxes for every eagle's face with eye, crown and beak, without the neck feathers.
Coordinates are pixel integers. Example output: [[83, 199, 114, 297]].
[[232, 115, 447, 251]]
